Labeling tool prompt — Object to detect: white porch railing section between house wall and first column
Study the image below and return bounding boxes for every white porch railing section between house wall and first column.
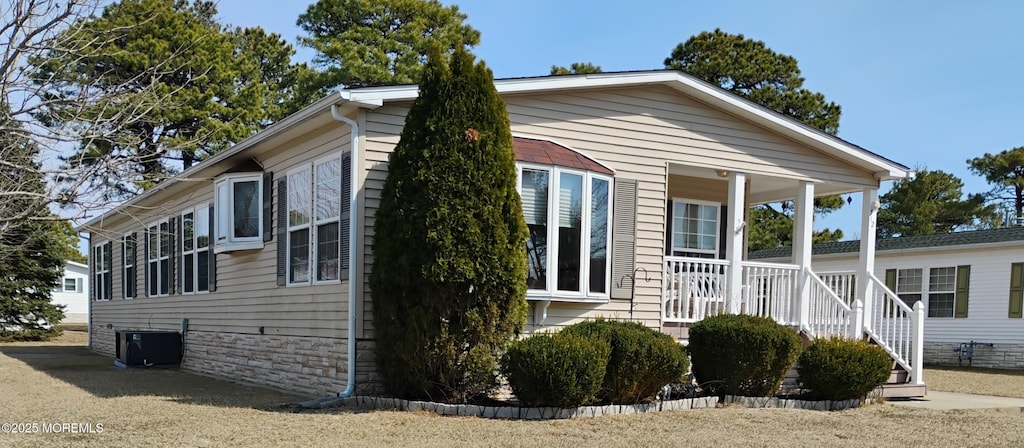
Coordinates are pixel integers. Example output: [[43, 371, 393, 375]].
[[662, 257, 729, 322]]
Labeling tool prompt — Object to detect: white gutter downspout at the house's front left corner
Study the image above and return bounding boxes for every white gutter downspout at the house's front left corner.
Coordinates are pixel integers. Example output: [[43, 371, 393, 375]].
[[331, 104, 359, 398]]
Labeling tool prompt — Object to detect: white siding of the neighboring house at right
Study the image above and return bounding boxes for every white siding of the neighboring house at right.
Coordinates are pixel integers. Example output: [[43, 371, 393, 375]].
[[813, 244, 1024, 344]]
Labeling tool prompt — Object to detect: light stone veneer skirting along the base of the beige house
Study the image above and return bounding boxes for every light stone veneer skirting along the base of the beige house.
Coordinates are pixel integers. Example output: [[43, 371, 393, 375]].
[[92, 326, 379, 396]]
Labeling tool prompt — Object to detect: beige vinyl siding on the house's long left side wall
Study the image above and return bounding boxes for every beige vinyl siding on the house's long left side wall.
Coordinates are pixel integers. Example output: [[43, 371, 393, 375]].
[[92, 124, 350, 339]]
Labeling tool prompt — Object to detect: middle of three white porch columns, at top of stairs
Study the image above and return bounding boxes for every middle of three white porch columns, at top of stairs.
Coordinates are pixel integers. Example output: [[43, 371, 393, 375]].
[[793, 180, 814, 328]]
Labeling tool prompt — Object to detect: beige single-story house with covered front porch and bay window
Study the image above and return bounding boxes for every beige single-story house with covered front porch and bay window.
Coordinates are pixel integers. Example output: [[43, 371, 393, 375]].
[[83, 71, 923, 395]]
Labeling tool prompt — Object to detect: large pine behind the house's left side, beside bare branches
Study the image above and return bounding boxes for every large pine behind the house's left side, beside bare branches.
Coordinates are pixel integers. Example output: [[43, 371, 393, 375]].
[[30, 0, 308, 198]]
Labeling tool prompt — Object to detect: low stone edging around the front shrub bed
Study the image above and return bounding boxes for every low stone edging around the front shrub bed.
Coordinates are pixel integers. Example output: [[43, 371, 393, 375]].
[[330, 395, 861, 420]]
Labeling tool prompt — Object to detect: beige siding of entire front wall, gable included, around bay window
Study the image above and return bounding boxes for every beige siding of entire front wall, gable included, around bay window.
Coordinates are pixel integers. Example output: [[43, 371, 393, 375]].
[[362, 86, 878, 338]]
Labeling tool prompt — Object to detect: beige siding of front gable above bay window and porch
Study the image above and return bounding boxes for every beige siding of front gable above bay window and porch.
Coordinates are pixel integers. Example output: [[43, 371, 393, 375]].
[[505, 86, 878, 187]]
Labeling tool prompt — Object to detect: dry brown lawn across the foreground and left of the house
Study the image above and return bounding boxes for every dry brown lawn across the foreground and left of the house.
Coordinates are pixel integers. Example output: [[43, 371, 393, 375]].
[[6, 334, 1024, 448]]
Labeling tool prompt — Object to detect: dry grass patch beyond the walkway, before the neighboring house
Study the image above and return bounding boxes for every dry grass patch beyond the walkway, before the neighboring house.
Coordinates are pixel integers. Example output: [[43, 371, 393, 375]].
[[925, 367, 1024, 398]]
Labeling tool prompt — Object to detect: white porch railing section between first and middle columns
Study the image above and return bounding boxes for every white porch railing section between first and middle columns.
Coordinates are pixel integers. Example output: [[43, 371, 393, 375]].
[[739, 261, 800, 325]]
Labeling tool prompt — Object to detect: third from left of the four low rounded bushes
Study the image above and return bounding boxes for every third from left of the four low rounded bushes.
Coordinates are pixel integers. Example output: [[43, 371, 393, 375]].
[[687, 314, 803, 397]]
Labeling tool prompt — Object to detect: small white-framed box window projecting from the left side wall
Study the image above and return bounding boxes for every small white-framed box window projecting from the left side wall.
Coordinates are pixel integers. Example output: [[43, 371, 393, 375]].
[[214, 173, 263, 253]]
